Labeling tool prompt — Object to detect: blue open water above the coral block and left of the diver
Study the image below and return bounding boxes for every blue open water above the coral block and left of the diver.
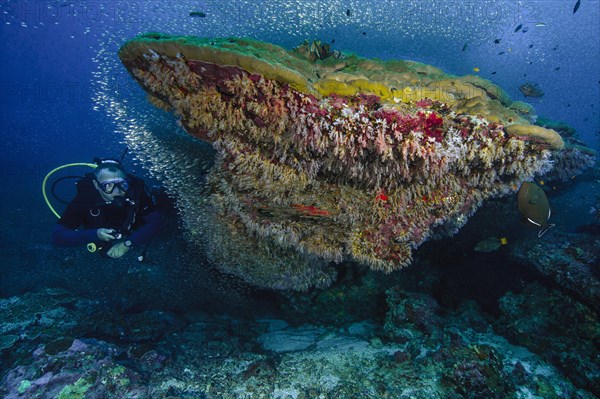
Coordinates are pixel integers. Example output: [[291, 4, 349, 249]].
[[0, 0, 600, 294]]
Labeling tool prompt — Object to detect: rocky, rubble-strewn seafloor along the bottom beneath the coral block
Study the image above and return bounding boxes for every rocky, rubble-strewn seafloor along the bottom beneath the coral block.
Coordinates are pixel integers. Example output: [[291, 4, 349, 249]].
[[0, 276, 600, 399]]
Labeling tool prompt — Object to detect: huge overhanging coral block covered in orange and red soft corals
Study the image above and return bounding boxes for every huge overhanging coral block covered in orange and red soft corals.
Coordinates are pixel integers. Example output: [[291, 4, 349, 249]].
[[119, 34, 561, 288]]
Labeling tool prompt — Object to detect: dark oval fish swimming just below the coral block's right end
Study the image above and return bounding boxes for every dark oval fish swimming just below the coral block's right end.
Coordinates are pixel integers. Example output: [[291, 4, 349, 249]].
[[517, 182, 554, 237]]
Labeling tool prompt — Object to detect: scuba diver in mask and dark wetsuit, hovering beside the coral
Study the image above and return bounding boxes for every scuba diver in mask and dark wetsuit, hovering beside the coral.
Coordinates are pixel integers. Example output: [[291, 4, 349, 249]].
[[52, 159, 162, 258]]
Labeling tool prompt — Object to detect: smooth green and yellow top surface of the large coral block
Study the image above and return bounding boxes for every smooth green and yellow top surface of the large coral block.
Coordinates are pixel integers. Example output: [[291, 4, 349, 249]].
[[119, 33, 548, 130]]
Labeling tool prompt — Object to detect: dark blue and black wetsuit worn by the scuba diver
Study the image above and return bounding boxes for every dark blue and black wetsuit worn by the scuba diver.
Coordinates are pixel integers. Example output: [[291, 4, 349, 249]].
[[52, 173, 161, 246]]
